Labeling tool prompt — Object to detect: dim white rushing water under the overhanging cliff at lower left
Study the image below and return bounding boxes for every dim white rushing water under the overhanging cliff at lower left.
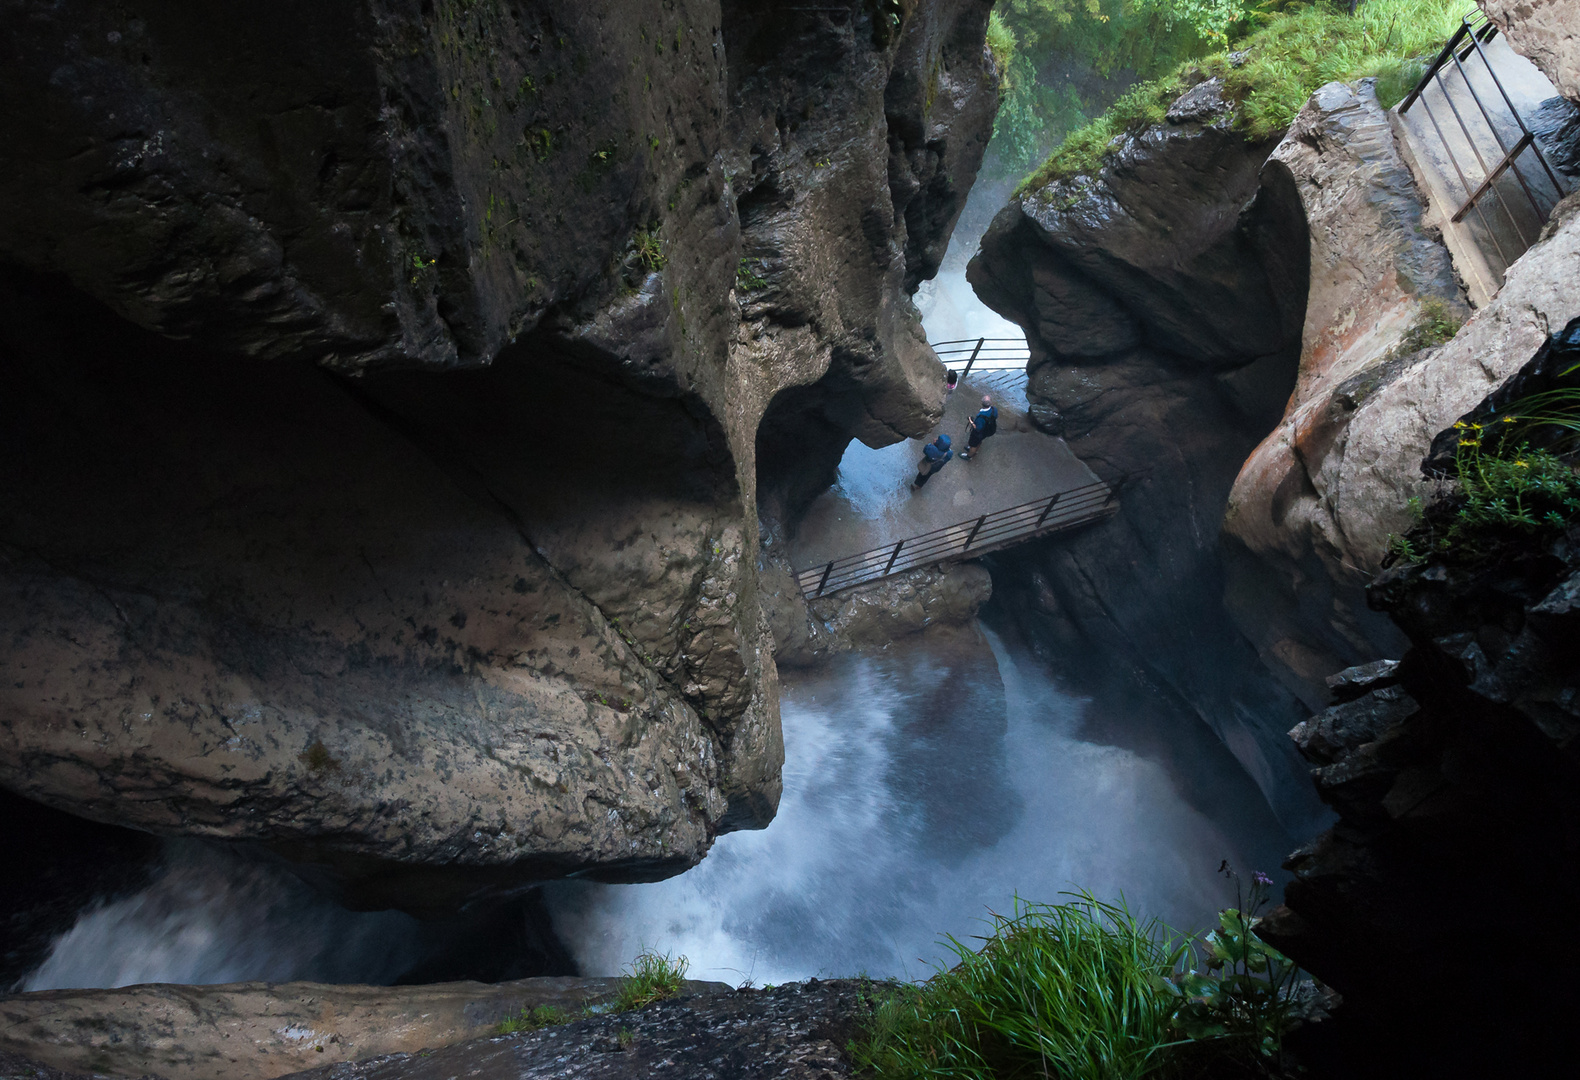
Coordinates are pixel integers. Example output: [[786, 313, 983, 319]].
[[19, 842, 420, 990]]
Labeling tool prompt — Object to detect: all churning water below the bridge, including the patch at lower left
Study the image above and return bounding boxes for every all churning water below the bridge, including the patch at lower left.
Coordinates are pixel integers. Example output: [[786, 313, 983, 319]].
[[24, 618, 1289, 990]]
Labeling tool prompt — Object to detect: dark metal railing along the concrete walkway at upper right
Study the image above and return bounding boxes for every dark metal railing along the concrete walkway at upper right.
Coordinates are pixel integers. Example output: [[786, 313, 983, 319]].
[[1398, 9, 1566, 281]]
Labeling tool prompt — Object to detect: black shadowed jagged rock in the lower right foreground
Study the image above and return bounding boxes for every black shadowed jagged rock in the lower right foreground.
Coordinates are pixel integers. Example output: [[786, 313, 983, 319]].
[[1264, 331, 1580, 1075]]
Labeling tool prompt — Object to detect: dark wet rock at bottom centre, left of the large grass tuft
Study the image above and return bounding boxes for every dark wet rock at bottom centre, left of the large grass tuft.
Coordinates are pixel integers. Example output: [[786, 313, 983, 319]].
[[271, 979, 863, 1080]]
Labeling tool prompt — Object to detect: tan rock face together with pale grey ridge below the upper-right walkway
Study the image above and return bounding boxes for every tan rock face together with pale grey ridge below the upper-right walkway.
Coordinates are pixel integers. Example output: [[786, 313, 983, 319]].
[[1225, 82, 1580, 707]]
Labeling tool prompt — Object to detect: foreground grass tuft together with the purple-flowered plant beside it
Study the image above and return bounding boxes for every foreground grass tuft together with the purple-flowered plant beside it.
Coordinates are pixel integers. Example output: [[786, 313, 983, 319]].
[[850, 868, 1297, 1080]]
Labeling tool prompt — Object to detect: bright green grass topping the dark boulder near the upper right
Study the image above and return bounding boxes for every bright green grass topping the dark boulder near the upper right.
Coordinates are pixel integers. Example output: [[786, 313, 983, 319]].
[[1018, 0, 1465, 193]]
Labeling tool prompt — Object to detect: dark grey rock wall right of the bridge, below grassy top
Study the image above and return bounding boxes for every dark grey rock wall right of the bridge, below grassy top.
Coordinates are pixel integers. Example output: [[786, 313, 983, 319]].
[[967, 85, 1315, 829]]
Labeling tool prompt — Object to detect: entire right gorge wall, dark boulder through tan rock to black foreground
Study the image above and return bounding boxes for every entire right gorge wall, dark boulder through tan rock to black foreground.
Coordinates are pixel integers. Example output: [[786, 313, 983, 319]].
[[972, 5, 1580, 1075]]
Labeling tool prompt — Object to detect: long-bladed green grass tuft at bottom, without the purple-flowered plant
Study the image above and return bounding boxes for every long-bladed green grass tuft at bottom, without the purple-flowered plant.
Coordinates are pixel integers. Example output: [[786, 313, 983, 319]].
[[850, 894, 1187, 1080]]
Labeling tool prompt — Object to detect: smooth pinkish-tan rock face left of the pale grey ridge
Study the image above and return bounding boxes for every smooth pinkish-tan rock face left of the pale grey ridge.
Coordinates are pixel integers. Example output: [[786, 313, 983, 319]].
[[1223, 79, 1469, 707]]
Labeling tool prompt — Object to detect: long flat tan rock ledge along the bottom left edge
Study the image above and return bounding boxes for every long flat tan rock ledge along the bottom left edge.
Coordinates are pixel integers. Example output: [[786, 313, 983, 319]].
[[0, 979, 728, 1080]]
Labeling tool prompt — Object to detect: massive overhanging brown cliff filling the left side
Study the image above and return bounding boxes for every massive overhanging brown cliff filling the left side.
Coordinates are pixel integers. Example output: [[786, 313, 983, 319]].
[[0, 0, 997, 908]]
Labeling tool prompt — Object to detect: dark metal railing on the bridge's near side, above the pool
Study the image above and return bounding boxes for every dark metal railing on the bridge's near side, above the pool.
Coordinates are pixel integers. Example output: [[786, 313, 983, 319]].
[[795, 480, 1119, 600]]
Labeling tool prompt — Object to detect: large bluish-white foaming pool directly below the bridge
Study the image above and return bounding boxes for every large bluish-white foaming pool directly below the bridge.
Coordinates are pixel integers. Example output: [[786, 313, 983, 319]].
[[551, 635, 1286, 984]]
